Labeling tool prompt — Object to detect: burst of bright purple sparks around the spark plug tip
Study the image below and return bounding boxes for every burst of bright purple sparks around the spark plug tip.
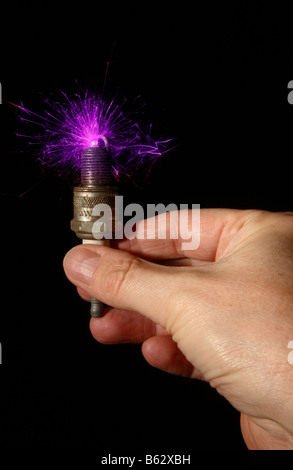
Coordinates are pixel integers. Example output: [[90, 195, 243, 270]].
[[18, 92, 172, 178]]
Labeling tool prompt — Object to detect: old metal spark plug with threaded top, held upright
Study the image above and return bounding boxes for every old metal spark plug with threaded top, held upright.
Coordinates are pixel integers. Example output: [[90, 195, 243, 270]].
[[71, 145, 119, 318]]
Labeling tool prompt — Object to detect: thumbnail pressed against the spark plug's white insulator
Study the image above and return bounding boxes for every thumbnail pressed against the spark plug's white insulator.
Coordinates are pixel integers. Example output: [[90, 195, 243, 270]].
[[64, 248, 100, 285]]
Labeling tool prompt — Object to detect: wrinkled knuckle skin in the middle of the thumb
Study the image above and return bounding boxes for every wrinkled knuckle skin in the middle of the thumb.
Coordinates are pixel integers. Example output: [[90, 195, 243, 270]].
[[101, 255, 139, 297]]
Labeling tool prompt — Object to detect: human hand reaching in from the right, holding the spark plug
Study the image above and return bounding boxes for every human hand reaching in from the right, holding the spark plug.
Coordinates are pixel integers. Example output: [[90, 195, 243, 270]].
[[64, 209, 293, 449]]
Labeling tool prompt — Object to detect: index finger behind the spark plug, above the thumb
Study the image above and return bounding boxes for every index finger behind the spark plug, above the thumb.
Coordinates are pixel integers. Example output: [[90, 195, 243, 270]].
[[113, 209, 244, 262]]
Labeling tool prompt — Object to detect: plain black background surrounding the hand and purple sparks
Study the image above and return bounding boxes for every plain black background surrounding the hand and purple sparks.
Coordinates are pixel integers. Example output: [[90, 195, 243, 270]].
[[0, 1, 293, 456]]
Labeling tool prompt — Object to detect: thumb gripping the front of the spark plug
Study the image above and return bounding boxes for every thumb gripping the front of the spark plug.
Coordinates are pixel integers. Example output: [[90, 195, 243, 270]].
[[64, 245, 200, 334]]
